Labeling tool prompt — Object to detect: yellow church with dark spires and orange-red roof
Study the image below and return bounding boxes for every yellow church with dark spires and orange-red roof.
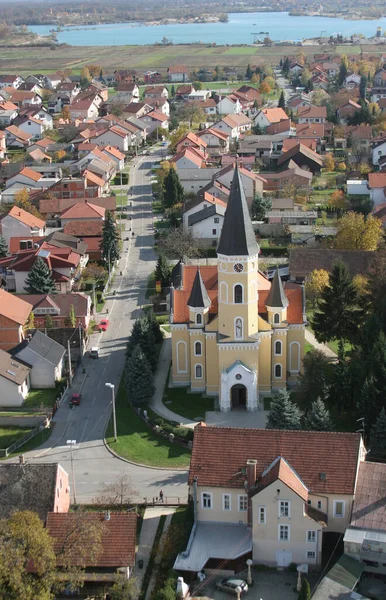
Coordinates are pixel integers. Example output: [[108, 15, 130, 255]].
[[170, 166, 306, 411]]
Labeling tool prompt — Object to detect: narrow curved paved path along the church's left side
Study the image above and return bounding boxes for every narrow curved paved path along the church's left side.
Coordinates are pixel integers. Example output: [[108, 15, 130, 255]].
[[149, 338, 197, 429]]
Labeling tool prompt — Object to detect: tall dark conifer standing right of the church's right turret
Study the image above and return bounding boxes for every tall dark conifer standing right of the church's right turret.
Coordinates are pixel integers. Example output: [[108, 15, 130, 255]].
[[312, 262, 361, 342]]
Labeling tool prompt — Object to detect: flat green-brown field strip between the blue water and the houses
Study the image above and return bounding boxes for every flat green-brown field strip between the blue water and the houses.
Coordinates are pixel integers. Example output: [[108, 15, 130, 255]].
[[0, 44, 381, 75]]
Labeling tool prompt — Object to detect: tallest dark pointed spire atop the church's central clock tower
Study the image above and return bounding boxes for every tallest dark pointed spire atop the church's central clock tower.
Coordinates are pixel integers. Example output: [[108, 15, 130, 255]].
[[217, 164, 259, 256]]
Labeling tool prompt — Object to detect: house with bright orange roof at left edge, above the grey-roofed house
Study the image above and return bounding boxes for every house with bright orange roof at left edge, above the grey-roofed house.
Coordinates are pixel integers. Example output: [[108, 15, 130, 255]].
[[0, 288, 32, 350]]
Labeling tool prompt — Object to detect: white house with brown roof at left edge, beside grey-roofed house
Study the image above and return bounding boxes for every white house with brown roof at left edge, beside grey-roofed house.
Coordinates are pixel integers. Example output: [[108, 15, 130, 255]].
[[0, 350, 31, 406]]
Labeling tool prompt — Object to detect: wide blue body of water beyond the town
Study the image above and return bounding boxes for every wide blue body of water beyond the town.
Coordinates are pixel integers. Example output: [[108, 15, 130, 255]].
[[29, 12, 386, 46]]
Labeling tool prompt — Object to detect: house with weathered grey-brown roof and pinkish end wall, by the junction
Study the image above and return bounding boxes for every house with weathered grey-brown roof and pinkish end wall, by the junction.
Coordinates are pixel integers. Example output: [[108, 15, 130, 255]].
[[0, 462, 70, 523]]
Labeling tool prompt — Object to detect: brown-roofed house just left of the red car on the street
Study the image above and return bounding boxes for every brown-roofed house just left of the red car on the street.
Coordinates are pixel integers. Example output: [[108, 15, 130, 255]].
[[18, 292, 92, 328]]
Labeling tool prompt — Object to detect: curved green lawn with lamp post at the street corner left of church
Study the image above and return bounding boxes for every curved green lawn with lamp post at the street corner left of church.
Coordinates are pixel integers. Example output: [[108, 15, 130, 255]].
[[106, 383, 190, 469]]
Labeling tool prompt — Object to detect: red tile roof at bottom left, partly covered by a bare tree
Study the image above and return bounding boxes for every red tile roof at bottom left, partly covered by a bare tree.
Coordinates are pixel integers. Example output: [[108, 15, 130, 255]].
[[47, 511, 137, 567]]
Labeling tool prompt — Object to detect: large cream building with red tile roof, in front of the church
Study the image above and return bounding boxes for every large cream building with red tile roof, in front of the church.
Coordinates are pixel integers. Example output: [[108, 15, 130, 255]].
[[174, 424, 365, 573]]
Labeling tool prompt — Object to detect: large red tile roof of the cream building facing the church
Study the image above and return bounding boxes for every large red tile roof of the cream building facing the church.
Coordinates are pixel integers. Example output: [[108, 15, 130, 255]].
[[189, 425, 361, 494]]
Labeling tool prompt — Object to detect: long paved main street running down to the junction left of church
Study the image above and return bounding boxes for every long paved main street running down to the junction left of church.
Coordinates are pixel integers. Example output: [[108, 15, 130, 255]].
[[8, 148, 187, 503]]
